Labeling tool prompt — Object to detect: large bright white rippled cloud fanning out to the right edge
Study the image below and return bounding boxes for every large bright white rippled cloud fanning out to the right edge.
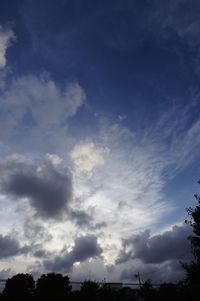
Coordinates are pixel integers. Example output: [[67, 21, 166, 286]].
[[71, 98, 200, 262]]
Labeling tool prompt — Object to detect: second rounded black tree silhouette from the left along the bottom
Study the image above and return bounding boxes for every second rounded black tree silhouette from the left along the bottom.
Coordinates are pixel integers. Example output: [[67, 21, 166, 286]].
[[35, 273, 72, 301]]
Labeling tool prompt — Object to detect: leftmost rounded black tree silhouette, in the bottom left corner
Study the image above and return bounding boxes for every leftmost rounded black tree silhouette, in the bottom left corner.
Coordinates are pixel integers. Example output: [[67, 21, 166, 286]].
[[3, 274, 35, 300]]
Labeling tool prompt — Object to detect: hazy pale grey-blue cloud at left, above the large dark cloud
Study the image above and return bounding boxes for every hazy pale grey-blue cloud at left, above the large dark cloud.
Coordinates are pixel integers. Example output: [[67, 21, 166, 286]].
[[0, 74, 86, 135]]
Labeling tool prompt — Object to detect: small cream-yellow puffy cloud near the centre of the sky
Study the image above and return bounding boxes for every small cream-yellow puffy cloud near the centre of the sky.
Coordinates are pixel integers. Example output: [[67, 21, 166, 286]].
[[71, 140, 109, 174]]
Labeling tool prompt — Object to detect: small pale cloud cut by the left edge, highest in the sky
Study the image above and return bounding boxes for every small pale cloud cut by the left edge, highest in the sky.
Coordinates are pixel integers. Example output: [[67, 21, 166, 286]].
[[0, 25, 15, 69]]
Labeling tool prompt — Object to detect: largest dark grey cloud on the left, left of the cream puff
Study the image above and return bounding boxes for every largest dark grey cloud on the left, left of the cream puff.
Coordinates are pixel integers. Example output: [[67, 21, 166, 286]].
[[0, 158, 73, 219]]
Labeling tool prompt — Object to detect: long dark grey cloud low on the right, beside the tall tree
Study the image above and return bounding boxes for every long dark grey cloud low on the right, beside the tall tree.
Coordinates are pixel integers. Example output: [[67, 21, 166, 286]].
[[117, 226, 191, 263]]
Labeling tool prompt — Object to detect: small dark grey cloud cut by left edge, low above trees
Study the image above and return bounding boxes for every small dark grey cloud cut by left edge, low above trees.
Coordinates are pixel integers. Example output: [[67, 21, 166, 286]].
[[0, 234, 29, 259]]
